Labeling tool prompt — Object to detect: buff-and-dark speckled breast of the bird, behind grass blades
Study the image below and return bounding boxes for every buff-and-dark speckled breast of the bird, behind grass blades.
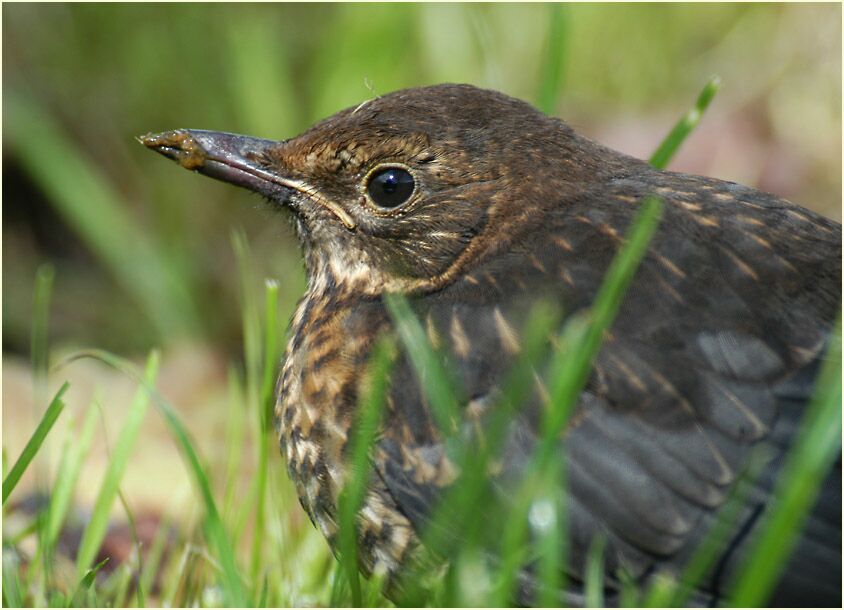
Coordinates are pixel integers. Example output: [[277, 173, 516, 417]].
[[276, 294, 415, 574]]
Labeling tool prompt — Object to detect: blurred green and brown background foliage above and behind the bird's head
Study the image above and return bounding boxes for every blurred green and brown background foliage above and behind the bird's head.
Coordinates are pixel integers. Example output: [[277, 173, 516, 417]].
[[2, 4, 841, 353]]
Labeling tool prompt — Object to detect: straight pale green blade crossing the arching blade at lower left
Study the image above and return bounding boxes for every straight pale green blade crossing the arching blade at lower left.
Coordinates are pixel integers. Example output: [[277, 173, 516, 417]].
[[76, 352, 159, 578]]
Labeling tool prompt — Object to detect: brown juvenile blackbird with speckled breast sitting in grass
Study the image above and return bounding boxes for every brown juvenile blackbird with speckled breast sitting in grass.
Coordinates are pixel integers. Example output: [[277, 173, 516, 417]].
[[142, 85, 841, 606]]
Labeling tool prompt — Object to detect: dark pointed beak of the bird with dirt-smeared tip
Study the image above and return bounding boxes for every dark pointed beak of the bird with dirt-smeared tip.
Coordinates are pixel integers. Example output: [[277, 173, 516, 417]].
[[138, 129, 289, 198]]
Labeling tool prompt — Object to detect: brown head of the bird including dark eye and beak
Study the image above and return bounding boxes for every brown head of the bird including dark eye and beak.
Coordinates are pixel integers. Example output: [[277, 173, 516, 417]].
[[141, 85, 624, 294]]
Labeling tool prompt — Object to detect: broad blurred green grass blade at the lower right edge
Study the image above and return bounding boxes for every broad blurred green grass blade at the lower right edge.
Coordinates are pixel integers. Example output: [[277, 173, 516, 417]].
[[731, 317, 841, 607]]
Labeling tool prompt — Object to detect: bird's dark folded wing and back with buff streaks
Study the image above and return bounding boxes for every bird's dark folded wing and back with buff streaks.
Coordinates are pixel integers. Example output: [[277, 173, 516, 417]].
[[376, 173, 841, 603]]
